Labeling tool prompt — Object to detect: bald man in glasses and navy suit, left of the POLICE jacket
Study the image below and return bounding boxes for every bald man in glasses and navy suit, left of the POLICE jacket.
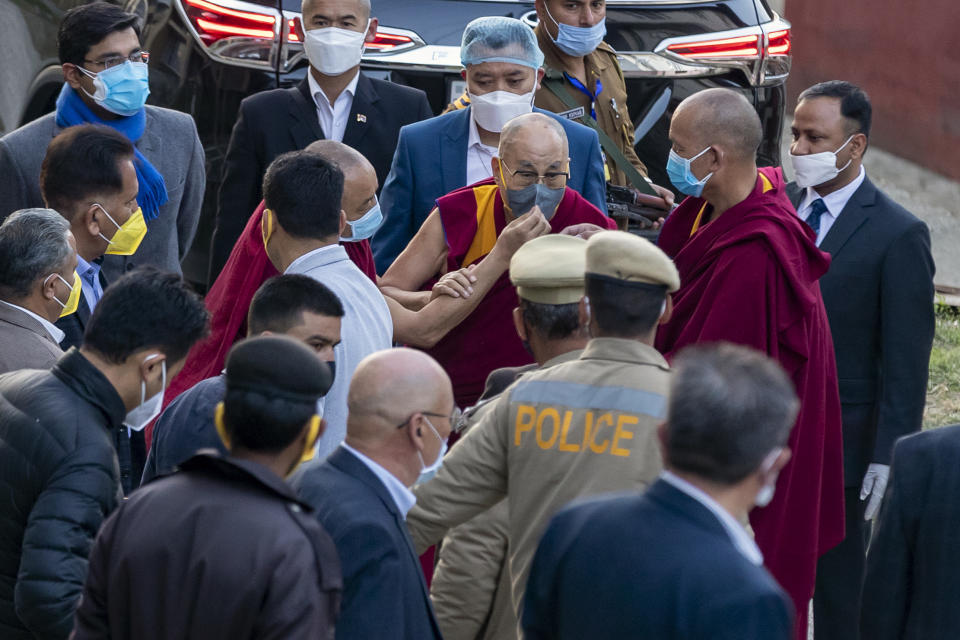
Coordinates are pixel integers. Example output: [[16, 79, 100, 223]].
[[294, 349, 458, 640]]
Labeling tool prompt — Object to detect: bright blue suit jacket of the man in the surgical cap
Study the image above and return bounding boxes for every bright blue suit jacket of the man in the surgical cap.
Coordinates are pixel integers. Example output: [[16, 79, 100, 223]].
[[372, 107, 607, 273]]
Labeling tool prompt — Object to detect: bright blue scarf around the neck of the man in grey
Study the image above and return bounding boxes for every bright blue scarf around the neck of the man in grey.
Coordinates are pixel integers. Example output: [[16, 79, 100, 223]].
[[57, 82, 168, 220]]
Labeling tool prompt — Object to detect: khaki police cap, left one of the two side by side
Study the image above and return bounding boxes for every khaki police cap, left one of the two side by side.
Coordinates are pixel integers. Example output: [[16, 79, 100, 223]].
[[510, 234, 587, 304]]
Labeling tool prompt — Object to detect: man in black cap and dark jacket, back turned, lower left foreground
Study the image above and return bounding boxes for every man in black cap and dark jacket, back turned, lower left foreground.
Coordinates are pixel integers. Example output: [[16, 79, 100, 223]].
[[72, 336, 342, 640]]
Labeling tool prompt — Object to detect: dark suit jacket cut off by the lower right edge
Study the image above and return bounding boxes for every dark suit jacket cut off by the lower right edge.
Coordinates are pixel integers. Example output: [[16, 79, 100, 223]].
[[860, 426, 960, 640]]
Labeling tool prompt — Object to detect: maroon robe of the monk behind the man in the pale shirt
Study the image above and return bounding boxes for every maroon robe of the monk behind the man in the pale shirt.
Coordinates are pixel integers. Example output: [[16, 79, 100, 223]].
[[145, 201, 377, 447]]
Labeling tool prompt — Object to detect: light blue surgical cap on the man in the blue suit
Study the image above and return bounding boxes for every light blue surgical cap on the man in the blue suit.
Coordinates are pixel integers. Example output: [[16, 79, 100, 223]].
[[460, 16, 543, 69]]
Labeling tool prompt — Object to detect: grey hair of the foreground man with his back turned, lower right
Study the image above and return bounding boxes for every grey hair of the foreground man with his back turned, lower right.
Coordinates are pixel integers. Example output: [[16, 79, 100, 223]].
[[665, 343, 800, 485]]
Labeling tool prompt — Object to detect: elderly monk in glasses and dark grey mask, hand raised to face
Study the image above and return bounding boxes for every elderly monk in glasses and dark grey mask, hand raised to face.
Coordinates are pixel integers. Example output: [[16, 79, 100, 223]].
[[380, 113, 615, 407]]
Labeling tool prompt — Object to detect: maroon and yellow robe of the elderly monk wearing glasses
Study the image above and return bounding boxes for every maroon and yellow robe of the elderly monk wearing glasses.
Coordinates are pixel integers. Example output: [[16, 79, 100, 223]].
[[428, 178, 616, 407]]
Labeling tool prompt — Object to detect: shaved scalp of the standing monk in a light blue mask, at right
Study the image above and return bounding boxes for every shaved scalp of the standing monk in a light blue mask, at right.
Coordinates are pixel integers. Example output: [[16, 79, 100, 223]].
[[670, 89, 763, 162]]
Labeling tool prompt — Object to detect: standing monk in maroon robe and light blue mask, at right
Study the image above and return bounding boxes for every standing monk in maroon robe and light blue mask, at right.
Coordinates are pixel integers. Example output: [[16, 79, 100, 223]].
[[656, 89, 844, 639]]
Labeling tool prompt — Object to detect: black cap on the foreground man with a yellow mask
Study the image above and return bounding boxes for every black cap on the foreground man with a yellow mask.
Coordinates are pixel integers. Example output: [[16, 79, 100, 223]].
[[227, 336, 333, 403]]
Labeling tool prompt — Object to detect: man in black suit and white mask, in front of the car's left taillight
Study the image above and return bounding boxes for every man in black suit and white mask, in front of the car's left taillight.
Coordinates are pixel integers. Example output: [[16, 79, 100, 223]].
[[214, 0, 433, 284]]
